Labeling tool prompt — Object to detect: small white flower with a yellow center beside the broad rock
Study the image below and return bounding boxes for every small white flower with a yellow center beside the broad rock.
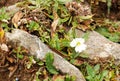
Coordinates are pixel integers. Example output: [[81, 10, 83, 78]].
[[70, 38, 87, 53]]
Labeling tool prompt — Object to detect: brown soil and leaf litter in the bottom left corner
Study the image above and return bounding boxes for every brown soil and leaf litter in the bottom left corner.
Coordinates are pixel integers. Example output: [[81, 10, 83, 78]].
[[0, 47, 39, 81]]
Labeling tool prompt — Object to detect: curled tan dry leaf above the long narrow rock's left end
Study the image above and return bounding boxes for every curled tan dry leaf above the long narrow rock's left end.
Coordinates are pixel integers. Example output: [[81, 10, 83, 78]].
[[12, 11, 23, 28]]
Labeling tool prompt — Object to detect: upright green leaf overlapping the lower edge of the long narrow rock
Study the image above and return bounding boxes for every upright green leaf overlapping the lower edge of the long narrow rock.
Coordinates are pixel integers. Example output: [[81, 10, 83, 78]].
[[45, 53, 58, 74]]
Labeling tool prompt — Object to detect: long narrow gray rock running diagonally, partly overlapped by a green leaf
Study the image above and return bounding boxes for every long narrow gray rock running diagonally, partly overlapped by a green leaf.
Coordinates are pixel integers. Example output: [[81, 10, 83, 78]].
[[5, 29, 85, 81]]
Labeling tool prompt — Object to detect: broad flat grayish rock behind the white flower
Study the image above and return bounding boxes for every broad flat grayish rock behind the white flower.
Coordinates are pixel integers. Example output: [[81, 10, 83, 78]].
[[76, 30, 120, 61]]
